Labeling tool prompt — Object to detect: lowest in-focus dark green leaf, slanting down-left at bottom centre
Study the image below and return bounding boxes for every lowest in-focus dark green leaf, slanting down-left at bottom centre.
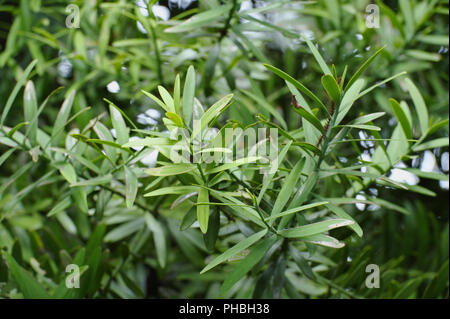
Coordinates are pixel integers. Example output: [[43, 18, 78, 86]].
[[220, 235, 278, 296]]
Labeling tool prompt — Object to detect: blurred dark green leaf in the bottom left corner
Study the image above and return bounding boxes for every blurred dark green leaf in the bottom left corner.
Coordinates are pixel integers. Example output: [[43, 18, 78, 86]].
[[5, 254, 49, 299]]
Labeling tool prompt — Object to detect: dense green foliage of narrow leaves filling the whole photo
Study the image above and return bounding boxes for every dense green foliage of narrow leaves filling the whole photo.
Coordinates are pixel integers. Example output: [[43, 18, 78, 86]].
[[0, 0, 449, 298]]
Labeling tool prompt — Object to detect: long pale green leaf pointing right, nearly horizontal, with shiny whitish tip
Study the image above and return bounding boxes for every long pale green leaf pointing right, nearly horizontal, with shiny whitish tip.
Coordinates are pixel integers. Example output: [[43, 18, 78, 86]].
[[279, 219, 355, 238]]
